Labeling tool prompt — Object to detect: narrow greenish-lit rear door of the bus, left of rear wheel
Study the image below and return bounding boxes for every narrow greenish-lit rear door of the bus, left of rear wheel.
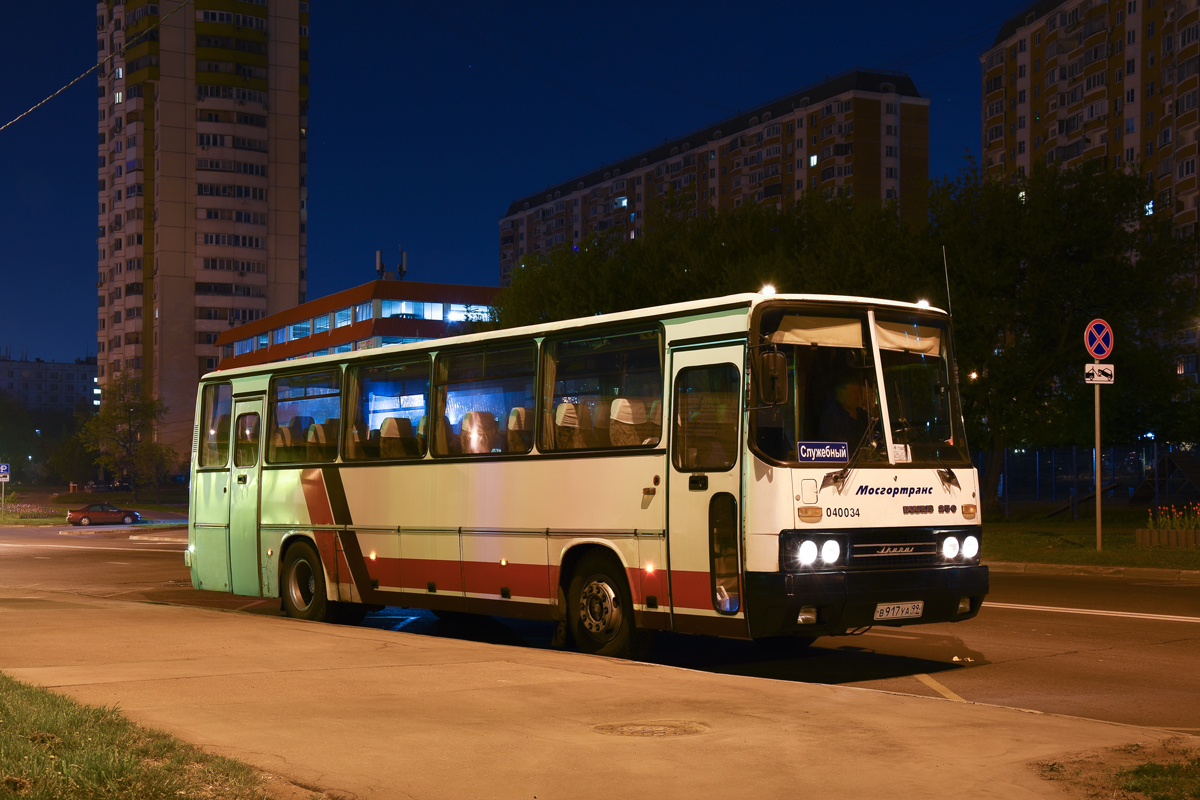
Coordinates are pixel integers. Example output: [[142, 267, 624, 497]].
[[229, 397, 263, 596]]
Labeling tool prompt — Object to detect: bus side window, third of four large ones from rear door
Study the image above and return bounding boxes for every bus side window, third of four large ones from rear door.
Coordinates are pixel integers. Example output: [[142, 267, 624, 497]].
[[436, 343, 538, 456]]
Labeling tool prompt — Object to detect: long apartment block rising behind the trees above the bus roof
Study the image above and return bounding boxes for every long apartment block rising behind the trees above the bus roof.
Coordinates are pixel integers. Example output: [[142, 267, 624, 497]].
[[499, 71, 929, 287]]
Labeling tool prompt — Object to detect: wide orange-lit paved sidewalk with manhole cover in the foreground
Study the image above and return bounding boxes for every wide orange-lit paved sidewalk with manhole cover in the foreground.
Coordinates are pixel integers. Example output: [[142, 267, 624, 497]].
[[0, 590, 1170, 800]]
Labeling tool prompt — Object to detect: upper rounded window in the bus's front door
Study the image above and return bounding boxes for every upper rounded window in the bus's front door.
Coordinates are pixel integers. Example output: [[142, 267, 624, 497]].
[[671, 363, 742, 471]]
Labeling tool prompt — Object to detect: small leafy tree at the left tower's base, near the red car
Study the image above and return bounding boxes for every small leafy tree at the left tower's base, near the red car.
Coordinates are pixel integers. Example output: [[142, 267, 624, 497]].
[[80, 371, 167, 500]]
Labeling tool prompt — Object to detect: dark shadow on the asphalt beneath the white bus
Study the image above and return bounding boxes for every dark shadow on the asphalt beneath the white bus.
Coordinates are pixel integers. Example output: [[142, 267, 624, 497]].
[[362, 608, 990, 685]]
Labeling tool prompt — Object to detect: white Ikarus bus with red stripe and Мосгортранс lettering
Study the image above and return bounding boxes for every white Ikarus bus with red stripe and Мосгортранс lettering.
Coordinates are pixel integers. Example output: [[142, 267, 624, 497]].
[[186, 294, 988, 655]]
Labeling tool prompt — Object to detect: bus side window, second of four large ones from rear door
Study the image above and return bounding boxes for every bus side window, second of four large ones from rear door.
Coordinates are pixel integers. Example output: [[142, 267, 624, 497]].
[[344, 359, 430, 461]]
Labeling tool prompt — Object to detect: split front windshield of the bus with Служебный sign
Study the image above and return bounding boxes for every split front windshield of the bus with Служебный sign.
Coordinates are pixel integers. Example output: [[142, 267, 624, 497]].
[[750, 306, 970, 467]]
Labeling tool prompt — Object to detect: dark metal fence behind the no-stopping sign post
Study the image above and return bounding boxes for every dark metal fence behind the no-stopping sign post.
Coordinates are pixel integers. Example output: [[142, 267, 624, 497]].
[[972, 443, 1198, 516]]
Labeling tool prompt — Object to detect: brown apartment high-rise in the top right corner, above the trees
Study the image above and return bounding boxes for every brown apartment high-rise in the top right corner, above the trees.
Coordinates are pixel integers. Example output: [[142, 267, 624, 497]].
[[980, 0, 1200, 231]]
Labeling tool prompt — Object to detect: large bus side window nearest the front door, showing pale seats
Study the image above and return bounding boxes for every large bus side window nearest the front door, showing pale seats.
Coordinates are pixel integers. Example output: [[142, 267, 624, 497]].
[[538, 330, 662, 451]]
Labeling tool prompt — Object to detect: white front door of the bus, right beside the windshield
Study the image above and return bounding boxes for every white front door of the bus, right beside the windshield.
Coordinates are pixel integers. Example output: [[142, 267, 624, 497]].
[[667, 343, 748, 637]]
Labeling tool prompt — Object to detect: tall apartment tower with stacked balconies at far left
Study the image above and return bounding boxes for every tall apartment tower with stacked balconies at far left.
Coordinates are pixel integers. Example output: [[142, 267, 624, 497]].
[[96, 0, 308, 457]]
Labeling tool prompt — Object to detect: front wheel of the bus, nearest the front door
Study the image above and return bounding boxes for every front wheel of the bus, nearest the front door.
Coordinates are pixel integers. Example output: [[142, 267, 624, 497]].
[[566, 551, 653, 658]]
